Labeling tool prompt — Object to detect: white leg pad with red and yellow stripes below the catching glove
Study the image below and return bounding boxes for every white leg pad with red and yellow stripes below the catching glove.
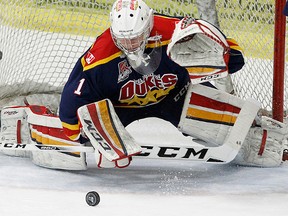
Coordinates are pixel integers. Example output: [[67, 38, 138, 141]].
[[178, 84, 245, 146]]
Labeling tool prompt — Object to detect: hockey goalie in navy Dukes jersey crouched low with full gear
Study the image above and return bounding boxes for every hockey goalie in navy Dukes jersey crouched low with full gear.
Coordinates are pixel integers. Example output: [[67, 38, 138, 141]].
[[1, 0, 287, 170]]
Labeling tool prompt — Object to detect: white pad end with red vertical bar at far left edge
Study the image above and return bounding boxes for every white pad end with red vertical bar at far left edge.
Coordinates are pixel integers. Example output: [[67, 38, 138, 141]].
[[0, 106, 30, 157]]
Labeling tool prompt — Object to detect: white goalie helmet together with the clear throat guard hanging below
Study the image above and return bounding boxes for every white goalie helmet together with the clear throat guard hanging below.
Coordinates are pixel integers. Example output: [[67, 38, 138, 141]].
[[110, 0, 161, 75]]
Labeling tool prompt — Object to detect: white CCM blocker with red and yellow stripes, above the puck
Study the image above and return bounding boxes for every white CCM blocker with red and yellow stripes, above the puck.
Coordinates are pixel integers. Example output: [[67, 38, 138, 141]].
[[78, 99, 141, 161]]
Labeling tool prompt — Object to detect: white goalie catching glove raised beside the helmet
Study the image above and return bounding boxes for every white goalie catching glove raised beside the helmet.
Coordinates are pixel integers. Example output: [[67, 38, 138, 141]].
[[167, 17, 230, 84]]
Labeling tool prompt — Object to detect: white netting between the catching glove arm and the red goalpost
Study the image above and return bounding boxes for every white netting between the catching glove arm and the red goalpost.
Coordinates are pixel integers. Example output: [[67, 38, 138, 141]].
[[217, 0, 282, 110]]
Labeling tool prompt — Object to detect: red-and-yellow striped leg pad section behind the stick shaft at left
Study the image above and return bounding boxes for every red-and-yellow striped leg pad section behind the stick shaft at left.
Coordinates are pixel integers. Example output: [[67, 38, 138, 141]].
[[28, 106, 87, 170]]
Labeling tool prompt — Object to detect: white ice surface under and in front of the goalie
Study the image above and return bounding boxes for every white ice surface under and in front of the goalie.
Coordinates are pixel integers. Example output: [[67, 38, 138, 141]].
[[0, 119, 288, 216]]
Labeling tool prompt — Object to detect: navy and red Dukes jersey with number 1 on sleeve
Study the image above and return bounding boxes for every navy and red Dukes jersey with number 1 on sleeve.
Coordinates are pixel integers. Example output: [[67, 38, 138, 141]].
[[59, 15, 244, 140]]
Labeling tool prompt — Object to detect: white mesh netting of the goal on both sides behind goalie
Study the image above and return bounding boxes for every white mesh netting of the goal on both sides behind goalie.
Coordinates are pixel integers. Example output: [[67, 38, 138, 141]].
[[0, 0, 288, 118]]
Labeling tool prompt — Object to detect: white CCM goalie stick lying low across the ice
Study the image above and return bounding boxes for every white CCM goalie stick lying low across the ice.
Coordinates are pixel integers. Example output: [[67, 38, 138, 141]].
[[0, 97, 260, 163]]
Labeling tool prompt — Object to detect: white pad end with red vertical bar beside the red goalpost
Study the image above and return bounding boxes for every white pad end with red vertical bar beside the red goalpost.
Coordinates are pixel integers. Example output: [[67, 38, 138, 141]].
[[233, 116, 287, 167]]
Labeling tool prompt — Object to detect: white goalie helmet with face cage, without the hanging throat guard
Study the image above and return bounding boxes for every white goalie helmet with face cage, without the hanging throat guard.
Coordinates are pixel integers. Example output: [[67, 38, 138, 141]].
[[110, 0, 153, 55]]
